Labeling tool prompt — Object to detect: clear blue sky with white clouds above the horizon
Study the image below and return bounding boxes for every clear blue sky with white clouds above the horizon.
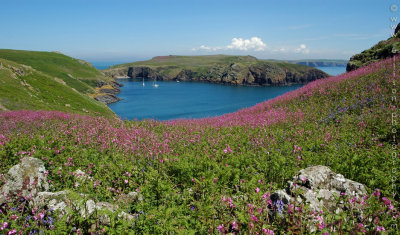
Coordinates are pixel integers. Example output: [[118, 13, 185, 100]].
[[0, 0, 394, 63]]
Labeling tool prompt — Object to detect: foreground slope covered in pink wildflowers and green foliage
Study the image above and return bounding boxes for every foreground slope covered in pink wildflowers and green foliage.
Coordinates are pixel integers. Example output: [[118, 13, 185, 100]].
[[0, 58, 400, 234]]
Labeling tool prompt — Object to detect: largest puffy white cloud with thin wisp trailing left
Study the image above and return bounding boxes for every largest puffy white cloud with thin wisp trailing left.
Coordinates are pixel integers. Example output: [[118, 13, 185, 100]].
[[192, 37, 267, 51]]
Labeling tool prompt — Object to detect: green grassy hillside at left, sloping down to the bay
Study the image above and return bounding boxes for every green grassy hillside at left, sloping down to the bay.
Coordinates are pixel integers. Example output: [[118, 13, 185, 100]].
[[0, 49, 114, 117]]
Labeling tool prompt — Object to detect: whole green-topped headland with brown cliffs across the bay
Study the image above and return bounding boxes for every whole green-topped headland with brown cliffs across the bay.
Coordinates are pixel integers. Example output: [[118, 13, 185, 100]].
[[103, 55, 329, 86]]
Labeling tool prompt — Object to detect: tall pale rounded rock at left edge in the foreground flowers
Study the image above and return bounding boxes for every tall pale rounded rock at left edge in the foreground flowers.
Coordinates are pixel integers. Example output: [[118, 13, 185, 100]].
[[0, 157, 49, 204]]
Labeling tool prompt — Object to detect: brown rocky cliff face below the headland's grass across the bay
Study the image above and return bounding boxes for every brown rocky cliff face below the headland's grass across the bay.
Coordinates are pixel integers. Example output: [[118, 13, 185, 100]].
[[122, 59, 328, 86]]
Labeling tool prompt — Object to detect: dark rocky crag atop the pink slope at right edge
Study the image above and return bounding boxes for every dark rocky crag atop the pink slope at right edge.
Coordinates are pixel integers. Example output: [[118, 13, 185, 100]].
[[346, 23, 400, 72]]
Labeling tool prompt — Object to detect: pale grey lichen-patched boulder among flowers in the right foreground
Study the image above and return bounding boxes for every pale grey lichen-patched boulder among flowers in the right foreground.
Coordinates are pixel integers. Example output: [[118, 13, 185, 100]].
[[271, 166, 367, 213]]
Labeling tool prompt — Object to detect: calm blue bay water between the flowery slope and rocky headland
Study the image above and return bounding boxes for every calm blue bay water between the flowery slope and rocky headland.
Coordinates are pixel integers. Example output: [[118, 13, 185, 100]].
[[109, 79, 301, 120]]
